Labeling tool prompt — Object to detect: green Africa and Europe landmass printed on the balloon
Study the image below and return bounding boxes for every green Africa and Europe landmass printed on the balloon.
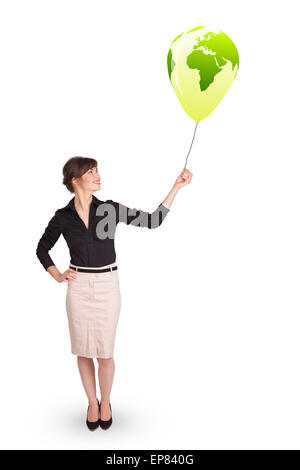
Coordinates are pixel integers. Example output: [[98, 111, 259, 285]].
[[186, 32, 239, 91]]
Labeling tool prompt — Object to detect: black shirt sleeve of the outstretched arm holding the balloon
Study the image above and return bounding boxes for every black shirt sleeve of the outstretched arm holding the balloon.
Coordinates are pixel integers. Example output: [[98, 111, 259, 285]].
[[109, 199, 170, 229]]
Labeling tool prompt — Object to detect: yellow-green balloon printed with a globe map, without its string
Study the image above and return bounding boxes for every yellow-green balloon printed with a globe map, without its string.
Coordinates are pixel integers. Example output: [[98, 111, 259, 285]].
[[167, 26, 239, 122]]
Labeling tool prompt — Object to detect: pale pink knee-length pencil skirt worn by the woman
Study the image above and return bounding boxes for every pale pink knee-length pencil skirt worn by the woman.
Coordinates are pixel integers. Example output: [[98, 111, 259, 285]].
[[66, 262, 121, 359]]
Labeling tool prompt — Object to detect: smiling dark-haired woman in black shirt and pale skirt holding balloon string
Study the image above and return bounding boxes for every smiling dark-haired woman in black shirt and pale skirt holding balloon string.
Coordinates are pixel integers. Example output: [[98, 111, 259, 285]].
[[36, 157, 192, 430]]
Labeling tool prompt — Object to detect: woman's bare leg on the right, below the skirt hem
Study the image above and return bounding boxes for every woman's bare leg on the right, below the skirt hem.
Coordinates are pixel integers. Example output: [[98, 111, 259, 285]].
[[97, 357, 115, 421]]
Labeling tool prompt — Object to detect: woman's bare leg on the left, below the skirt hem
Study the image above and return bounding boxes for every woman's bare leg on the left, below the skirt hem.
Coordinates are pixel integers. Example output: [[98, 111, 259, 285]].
[[77, 356, 99, 421]]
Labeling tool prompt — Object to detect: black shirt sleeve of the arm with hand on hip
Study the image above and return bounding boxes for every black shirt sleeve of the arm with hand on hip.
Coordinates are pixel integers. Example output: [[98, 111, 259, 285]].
[[36, 210, 62, 271]]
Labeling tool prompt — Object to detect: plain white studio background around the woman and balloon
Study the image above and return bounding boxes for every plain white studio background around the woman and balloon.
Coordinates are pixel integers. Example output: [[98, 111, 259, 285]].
[[0, 0, 300, 449]]
